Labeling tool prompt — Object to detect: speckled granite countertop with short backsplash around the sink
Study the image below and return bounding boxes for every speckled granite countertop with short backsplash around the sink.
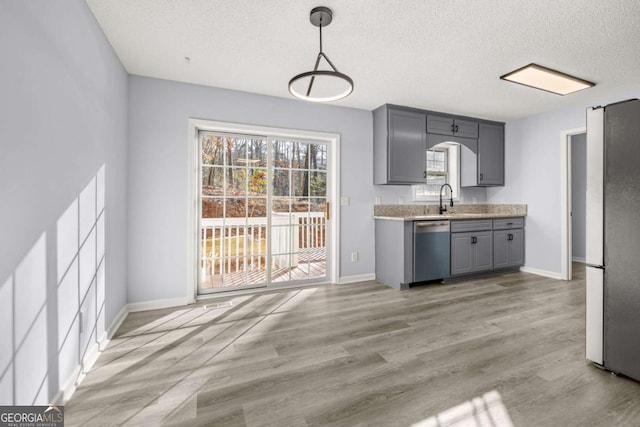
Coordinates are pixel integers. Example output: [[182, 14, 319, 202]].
[[373, 204, 527, 221]]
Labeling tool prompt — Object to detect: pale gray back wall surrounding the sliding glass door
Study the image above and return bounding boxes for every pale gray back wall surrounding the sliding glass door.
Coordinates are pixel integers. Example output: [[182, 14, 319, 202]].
[[128, 76, 374, 303]]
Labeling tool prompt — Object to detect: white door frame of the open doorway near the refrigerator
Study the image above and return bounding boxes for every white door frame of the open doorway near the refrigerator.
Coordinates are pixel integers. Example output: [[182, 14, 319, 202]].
[[560, 126, 587, 280]]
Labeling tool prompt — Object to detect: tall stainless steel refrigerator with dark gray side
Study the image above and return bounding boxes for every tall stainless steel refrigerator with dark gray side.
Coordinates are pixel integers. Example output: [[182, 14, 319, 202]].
[[586, 99, 640, 380]]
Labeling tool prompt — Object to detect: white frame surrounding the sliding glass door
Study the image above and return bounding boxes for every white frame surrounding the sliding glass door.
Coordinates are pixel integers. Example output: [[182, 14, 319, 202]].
[[185, 118, 340, 303]]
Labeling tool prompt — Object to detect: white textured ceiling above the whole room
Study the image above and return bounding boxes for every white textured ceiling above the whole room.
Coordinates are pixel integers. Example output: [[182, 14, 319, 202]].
[[87, 0, 640, 120]]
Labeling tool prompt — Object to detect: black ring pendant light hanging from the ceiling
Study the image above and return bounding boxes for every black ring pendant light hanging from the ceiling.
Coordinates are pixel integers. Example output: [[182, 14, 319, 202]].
[[289, 6, 353, 102]]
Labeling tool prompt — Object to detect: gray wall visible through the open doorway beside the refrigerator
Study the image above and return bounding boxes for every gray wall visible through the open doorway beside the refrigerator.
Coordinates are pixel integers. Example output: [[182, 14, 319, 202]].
[[571, 133, 587, 262]]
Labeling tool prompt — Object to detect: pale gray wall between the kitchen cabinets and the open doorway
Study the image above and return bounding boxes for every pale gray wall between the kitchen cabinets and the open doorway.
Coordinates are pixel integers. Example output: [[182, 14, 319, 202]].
[[487, 86, 640, 276]]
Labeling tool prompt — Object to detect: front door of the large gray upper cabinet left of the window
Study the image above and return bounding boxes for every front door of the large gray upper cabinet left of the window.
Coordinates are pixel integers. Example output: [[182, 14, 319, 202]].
[[388, 109, 427, 184]]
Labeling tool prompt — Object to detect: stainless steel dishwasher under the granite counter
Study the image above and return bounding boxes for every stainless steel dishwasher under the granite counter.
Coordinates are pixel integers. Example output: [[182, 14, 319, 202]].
[[413, 220, 451, 282]]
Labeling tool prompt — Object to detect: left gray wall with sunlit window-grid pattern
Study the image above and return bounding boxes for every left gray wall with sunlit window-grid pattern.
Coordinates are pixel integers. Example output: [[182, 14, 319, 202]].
[[0, 0, 127, 405]]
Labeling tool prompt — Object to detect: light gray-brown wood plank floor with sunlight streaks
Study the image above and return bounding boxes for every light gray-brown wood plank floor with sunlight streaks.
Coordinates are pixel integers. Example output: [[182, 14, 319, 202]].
[[65, 265, 640, 426]]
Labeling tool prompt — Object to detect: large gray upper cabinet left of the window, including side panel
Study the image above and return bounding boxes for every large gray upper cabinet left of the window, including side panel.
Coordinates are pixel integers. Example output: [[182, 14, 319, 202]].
[[373, 105, 427, 185]]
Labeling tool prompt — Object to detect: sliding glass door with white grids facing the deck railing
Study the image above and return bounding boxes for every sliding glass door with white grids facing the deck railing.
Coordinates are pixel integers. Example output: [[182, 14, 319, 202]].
[[198, 131, 331, 294]]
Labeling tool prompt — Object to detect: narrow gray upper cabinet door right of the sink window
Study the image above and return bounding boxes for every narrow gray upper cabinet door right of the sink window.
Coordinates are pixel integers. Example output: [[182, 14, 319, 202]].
[[478, 123, 504, 185]]
